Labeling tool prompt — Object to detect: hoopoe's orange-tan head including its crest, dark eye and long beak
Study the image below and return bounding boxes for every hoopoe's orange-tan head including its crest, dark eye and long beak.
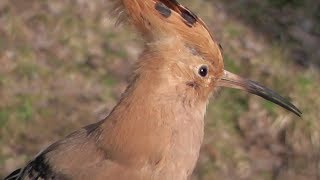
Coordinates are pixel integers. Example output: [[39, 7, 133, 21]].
[[111, 0, 301, 116]]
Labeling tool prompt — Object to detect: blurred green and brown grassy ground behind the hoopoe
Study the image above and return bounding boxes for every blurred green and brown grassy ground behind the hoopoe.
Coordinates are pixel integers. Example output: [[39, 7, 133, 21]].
[[0, 0, 320, 180]]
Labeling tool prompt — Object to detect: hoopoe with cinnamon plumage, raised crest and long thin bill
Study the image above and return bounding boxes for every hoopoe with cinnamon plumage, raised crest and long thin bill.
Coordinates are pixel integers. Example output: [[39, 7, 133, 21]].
[[5, 0, 302, 180]]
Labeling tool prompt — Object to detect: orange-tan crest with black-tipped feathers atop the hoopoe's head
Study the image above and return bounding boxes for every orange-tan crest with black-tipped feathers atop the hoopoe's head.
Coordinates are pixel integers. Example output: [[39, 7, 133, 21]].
[[112, 0, 223, 80]]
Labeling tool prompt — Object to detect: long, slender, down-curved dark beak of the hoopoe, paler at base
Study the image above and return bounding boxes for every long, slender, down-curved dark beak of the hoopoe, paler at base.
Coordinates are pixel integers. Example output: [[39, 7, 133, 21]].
[[218, 70, 302, 117]]
